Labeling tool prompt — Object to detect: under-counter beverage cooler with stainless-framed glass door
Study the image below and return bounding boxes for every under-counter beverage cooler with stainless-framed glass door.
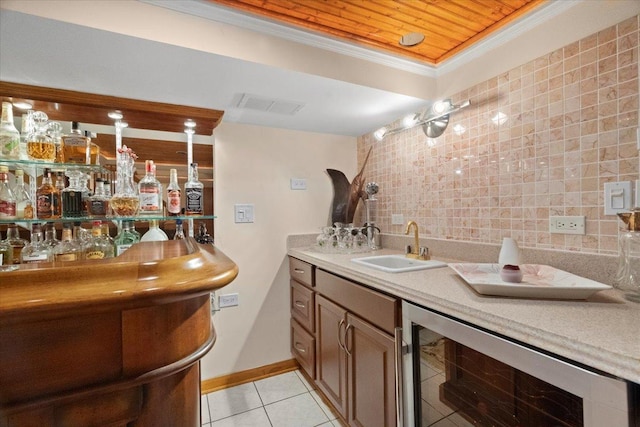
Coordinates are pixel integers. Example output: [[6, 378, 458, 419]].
[[396, 302, 640, 427]]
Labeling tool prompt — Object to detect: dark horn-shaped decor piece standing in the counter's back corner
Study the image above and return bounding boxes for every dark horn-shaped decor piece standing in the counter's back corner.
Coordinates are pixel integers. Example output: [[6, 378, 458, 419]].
[[327, 147, 373, 224]]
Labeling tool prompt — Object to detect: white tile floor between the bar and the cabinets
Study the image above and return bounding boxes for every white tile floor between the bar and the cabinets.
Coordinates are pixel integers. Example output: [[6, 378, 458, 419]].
[[201, 371, 342, 427]]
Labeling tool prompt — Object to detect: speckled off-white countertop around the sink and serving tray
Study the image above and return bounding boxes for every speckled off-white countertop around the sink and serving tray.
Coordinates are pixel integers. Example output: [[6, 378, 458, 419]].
[[288, 247, 640, 383]]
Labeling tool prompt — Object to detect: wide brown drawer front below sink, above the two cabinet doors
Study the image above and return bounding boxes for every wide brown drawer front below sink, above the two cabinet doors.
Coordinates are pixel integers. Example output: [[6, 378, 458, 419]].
[[316, 269, 400, 335]]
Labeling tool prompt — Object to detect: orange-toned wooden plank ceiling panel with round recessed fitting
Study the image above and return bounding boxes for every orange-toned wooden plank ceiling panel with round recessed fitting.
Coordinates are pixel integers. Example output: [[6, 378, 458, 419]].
[[208, 0, 547, 65]]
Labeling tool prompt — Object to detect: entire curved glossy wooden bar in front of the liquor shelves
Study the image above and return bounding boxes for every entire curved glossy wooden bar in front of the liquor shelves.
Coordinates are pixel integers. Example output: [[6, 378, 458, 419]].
[[0, 238, 238, 427]]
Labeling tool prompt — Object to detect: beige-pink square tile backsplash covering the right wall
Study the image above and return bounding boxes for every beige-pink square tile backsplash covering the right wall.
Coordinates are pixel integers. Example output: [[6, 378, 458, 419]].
[[358, 15, 640, 254]]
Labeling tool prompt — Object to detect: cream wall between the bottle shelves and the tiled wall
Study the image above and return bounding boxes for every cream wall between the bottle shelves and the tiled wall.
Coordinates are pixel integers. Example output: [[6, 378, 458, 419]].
[[202, 122, 357, 379]]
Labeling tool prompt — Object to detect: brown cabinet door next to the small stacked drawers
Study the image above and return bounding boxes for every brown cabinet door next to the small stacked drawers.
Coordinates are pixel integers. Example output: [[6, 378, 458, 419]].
[[316, 295, 347, 419]]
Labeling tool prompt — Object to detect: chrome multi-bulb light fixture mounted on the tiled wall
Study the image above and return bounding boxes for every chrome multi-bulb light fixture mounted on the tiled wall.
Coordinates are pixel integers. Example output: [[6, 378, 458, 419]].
[[373, 99, 471, 141]]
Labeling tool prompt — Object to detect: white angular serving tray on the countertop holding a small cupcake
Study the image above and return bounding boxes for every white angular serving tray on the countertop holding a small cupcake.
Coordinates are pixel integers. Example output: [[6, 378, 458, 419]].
[[449, 263, 611, 299]]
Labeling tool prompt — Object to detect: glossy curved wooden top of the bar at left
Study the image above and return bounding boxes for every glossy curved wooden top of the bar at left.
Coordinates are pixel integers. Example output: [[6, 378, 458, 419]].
[[0, 238, 238, 324]]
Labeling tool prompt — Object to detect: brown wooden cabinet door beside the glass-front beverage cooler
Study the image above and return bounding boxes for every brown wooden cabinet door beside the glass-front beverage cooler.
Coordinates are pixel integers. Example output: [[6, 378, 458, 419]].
[[345, 314, 396, 427]]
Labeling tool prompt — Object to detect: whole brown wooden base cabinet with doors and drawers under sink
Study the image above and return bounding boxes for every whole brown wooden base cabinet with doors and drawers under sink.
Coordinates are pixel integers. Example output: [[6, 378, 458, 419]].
[[290, 258, 401, 427]]
